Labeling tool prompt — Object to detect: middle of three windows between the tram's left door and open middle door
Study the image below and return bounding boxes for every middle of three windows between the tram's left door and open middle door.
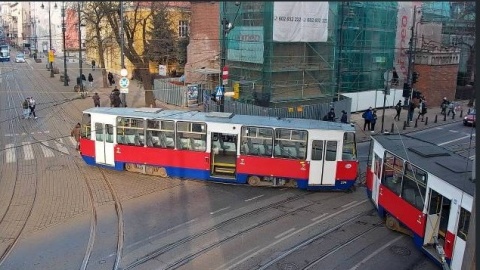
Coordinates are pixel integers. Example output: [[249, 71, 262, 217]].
[[145, 120, 175, 149]]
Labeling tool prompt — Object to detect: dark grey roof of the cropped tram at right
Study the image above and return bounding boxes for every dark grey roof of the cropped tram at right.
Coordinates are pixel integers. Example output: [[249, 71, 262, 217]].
[[372, 134, 475, 196]]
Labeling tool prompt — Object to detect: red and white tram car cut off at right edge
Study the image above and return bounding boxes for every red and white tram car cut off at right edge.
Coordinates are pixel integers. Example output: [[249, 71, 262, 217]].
[[366, 135, 475, 269]]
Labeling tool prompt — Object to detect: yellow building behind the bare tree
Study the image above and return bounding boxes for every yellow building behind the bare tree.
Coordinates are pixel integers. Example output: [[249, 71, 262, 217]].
[[86, 2, 190, 78]]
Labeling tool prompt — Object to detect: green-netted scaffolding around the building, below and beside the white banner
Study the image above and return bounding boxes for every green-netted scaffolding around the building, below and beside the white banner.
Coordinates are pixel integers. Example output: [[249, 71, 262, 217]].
[[220, 2, 397, 106]]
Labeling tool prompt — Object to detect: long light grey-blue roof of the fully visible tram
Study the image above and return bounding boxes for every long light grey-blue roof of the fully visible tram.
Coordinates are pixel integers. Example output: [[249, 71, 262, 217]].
[[84, 107, 355, 131]]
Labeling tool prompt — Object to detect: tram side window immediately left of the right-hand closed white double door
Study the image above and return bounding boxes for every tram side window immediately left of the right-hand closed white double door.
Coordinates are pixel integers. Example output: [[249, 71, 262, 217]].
[[274, 128, 308, 159]]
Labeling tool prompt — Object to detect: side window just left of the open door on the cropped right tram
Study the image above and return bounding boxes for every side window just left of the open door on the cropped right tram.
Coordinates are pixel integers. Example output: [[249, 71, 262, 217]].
[[402, 162, 427, 210]]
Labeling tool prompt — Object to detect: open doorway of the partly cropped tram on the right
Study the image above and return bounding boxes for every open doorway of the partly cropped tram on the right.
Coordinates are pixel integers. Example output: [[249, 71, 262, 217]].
[[423, 189, 451, 246]]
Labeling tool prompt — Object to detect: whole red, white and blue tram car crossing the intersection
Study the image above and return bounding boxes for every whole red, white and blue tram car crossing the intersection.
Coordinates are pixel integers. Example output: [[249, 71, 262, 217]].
[[80, 107, 358, 191]]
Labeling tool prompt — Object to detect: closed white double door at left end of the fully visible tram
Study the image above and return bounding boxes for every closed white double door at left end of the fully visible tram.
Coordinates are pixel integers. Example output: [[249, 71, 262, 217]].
[[95, 123, 115, 166]]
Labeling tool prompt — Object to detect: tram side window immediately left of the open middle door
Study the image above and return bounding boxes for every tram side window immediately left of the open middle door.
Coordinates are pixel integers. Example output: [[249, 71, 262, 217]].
[[177, 122, 207, 152]]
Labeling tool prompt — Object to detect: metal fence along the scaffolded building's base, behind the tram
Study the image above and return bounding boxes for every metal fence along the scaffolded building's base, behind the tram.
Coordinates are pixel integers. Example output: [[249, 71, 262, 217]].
[[153, 79, 352, 121]]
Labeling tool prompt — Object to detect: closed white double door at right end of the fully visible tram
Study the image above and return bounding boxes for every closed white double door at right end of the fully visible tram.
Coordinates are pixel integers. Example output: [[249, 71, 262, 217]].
[[308, 140, 340, 185]]
